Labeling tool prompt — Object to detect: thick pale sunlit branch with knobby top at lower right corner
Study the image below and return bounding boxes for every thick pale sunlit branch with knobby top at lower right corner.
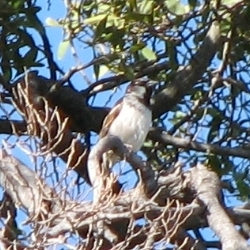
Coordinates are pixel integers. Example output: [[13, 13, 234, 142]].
[[190, 165, 250, 250]]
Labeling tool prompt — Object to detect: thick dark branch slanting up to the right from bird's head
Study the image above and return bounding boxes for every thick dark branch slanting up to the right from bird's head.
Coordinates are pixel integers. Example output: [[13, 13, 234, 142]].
[[152, 22, 221, 118]]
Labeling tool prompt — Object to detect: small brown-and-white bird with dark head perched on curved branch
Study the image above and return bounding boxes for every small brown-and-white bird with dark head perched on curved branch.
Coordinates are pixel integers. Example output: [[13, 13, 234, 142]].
[[99, 79, 152, 168]]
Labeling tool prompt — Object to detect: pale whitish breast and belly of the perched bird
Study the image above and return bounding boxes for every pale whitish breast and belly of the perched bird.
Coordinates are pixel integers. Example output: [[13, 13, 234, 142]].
[[109, 103, 152, 152]]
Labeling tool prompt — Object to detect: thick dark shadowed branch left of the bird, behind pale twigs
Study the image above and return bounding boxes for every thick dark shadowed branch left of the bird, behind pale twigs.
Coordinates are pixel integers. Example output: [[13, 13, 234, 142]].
[[12, 71, 108, 133]]
